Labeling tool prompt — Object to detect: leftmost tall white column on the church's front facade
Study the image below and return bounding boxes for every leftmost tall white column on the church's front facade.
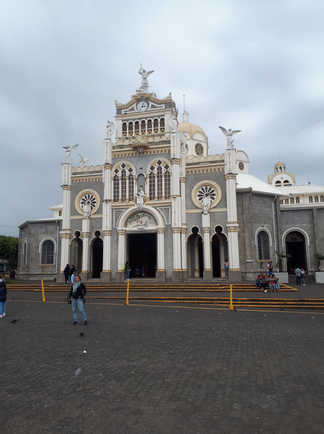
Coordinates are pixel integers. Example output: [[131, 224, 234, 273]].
[[58, 162, 72, 274]]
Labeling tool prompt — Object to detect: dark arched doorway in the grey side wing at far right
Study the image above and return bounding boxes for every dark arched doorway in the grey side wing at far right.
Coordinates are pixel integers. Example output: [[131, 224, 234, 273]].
[[286, 231, 307, 273]]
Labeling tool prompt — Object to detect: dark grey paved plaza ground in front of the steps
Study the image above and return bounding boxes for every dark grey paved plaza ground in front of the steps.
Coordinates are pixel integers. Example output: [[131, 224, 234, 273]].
[[0, 294, 324, 434]]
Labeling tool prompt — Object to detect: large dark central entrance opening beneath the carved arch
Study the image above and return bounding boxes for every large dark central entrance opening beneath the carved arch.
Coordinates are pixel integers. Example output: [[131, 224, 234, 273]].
[[127, 233, 157, 278]]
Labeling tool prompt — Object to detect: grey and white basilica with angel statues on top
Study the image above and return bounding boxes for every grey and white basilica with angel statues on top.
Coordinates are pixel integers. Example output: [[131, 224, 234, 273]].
[[17, 67, 324, 282]]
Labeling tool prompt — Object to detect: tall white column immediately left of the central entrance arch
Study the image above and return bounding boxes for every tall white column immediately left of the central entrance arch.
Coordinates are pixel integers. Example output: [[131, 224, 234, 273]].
[[101, 139, 112, 282]]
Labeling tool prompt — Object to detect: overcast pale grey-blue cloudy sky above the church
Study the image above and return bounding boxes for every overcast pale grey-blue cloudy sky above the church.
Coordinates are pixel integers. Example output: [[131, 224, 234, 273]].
[[0, 0, 324, 235]]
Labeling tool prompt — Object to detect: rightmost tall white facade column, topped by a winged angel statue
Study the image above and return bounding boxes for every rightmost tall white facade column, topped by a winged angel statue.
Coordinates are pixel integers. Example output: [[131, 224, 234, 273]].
[[225, 148, 241, 281]]
